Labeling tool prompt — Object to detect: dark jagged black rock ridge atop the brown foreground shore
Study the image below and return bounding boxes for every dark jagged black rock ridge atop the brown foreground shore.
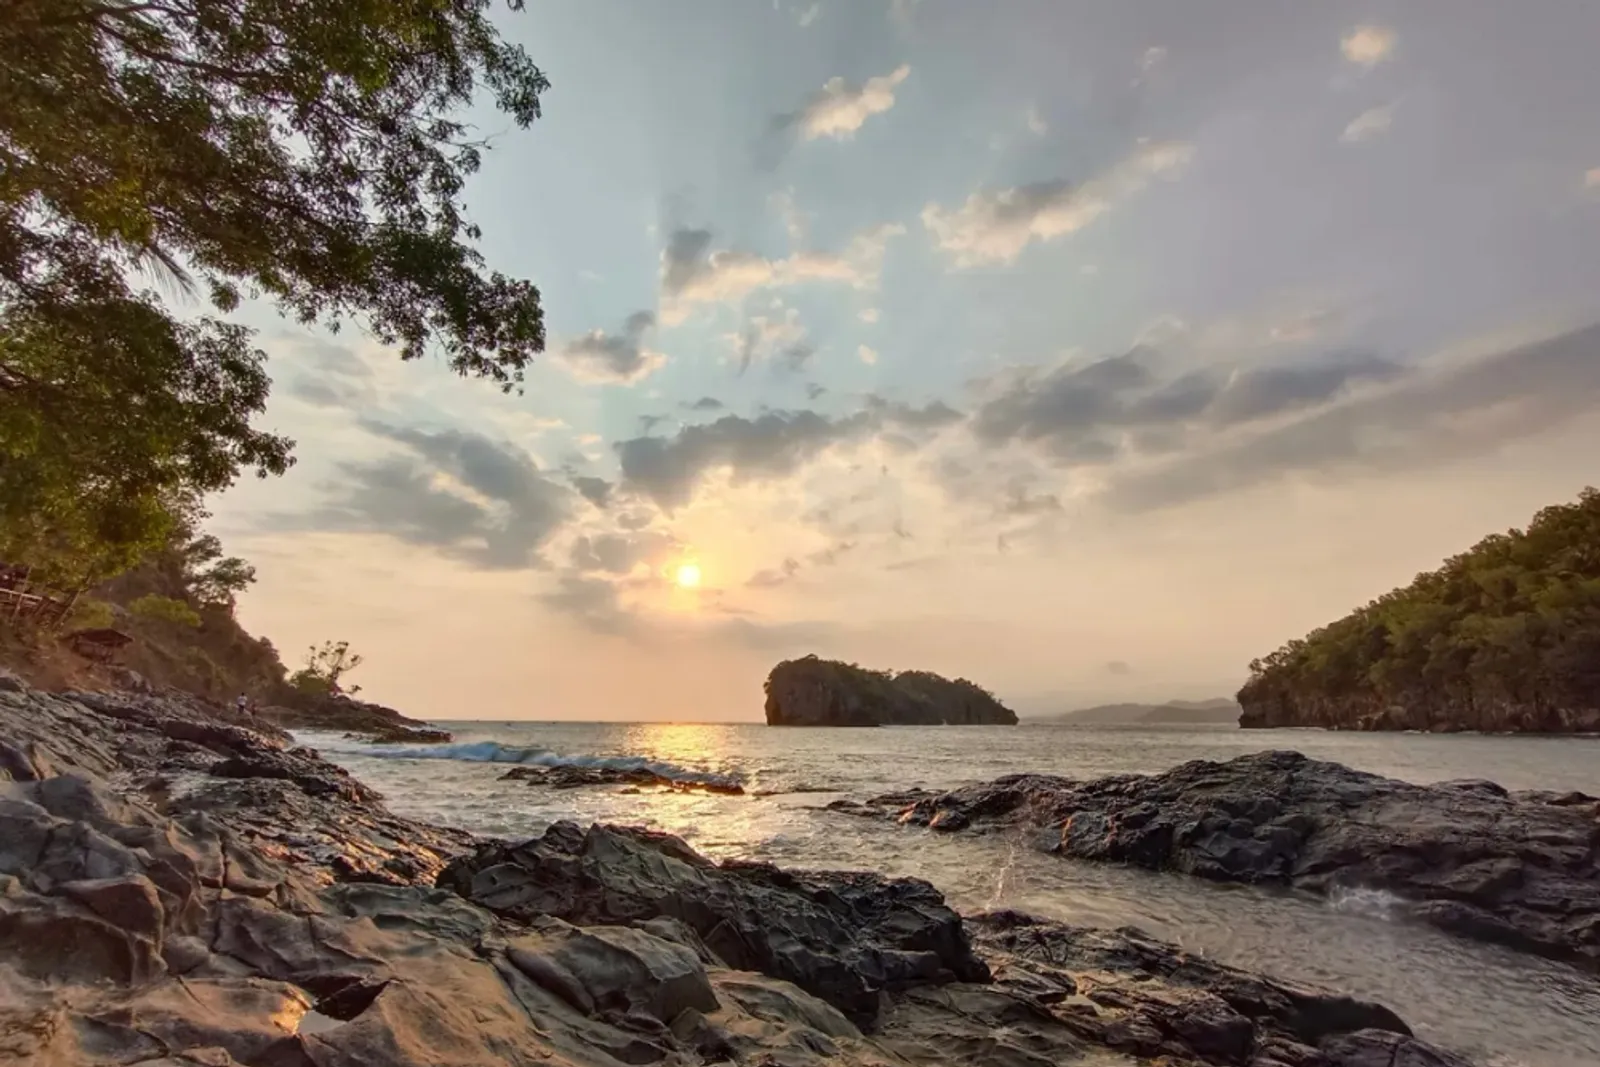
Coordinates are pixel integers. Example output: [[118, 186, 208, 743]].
[[438, 822, 989, 1024]]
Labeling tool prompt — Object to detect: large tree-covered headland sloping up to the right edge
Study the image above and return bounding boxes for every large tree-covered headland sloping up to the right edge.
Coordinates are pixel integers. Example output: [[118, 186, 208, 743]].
[[1238, 486, 1600, 733]]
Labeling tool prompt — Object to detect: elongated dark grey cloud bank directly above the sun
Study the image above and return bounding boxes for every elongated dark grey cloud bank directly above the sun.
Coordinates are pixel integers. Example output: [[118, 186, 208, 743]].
[[614, 398, 962, 510]]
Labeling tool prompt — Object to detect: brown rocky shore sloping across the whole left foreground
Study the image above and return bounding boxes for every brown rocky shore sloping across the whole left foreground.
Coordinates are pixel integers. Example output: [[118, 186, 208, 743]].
[[0, 677, 1464, 1067]]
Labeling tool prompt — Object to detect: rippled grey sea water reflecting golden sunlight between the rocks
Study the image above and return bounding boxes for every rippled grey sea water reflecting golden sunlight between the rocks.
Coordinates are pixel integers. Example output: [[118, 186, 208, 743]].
[[299, 723, 1600, 1067]]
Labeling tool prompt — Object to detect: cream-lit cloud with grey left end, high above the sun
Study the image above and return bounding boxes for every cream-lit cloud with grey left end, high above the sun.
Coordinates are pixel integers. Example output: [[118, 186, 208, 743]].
[[661, 224, 906, 323]]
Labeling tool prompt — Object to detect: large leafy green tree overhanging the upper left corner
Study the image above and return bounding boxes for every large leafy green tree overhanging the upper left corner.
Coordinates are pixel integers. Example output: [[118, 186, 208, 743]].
[[0, 0, 547, 581]]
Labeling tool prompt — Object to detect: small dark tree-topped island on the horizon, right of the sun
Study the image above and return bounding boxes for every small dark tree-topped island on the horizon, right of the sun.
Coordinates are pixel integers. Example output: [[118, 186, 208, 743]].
[[765, 656, 1016, 726]]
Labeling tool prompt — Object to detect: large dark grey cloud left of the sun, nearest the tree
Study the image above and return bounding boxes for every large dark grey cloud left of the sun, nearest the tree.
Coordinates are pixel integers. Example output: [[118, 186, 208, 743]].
[[309, 422, 573, 569]]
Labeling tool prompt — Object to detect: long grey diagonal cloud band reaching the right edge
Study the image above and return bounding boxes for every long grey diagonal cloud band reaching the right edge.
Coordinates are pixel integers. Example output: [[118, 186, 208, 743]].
[[1104, 325, 1600, 512]]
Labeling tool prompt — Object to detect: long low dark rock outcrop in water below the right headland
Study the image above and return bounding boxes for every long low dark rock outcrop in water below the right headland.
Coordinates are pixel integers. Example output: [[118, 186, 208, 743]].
[[832, 752, 1600, 968]]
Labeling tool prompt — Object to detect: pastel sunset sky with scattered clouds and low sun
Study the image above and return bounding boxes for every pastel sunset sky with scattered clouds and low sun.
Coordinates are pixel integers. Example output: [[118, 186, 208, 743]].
[[211, 0, 1600, 721]]
